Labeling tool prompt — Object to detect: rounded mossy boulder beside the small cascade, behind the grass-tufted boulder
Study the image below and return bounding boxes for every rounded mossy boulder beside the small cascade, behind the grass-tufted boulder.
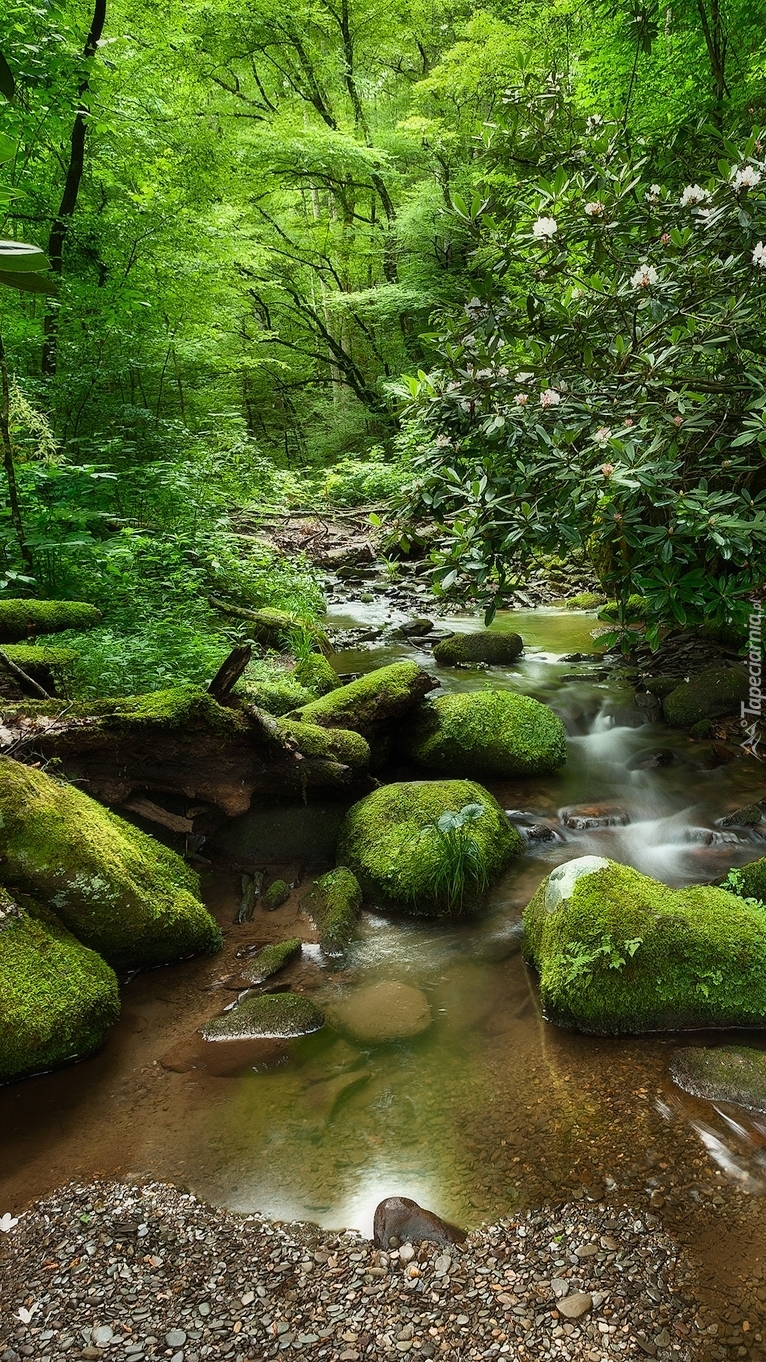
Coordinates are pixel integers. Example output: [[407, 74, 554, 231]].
[[401, 691, 567, 776]]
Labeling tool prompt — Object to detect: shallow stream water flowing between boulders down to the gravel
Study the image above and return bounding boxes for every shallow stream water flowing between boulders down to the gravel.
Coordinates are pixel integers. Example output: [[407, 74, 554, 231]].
[[0, 602, 766, 1263]]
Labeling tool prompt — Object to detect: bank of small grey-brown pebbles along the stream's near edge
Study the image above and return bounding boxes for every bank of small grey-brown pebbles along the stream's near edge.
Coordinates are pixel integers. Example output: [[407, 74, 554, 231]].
[[0, 1182, 699, 1362]]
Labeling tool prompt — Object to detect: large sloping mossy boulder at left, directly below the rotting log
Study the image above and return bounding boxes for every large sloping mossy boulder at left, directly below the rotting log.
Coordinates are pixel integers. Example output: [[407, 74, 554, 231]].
[[0, 757, 221, 968]]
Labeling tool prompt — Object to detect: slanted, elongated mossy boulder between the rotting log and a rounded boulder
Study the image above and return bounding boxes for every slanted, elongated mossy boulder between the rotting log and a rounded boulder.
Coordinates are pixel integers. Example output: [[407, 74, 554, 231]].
[[289, 662, 436, 737]]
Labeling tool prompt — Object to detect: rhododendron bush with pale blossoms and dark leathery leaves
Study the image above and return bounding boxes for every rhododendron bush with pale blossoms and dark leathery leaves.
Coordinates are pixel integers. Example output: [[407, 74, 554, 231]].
[[408, 90, 766, 643]]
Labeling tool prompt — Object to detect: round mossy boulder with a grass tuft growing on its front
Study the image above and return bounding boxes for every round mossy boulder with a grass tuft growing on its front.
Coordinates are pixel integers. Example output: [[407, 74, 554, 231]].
[[337, 780, 523, 917]]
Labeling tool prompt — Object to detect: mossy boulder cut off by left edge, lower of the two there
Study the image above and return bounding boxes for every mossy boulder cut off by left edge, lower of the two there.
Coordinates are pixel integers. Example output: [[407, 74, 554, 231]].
[[0, 888, 120, 1083]]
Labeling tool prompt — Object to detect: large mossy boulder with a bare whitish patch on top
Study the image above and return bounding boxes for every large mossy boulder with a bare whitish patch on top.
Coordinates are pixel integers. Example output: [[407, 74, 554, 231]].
[[523, 857, 766, 1035]]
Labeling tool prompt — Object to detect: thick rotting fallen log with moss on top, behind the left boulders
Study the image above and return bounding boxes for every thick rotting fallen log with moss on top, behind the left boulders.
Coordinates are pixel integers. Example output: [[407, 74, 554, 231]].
[[0, 686, 369, 816]]
